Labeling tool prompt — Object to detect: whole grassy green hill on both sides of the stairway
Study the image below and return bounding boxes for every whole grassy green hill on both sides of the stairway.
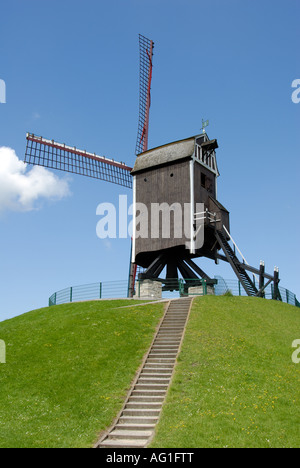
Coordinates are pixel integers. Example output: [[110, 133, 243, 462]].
[[0, 297, 300, 448]]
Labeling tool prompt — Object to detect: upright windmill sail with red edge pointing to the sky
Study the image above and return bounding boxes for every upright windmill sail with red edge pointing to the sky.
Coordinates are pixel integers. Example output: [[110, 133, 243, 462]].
[[136, 34, 154, 154]]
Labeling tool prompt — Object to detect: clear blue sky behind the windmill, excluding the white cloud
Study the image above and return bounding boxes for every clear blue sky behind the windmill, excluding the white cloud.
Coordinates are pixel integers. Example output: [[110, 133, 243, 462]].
[[0, 0, 300, 320]]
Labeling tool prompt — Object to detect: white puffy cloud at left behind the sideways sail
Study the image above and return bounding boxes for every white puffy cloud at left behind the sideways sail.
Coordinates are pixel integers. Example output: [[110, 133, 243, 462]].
[[0, 146, 70, 212]]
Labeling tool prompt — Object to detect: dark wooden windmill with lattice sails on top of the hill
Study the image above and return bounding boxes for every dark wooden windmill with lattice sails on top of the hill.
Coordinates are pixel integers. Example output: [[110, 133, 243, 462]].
[[25, 35, 281, 300]]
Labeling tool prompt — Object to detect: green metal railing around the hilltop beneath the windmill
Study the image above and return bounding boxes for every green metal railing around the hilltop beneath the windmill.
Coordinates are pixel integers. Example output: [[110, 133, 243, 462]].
[[49, 276, 300, 307]]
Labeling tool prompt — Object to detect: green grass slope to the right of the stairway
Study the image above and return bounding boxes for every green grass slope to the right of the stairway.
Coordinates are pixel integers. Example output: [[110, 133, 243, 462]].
[[152, 297, 300, 448]]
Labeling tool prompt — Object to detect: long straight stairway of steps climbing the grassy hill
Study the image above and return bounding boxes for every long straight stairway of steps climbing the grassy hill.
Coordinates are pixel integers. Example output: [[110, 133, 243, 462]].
[[96, 298, 192, 448]]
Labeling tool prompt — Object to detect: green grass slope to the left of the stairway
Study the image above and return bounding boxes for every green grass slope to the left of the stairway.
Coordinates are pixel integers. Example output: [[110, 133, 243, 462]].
[[0, 301, 163, 448]]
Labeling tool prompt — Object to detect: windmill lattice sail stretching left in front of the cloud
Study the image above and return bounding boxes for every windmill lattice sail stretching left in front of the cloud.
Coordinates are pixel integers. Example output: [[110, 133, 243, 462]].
[[25, 133, 132, 188]]
